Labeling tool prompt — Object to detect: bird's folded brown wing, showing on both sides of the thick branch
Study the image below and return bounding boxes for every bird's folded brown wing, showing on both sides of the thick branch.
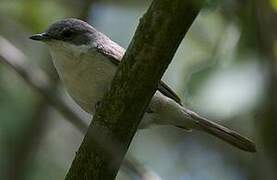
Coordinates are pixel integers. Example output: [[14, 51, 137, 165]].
[[97, 39, 182, 105]]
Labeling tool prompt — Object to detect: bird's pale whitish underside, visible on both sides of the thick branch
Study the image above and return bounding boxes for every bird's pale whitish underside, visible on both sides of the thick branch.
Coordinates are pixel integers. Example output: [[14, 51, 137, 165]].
[[45, 41, 191, 127]]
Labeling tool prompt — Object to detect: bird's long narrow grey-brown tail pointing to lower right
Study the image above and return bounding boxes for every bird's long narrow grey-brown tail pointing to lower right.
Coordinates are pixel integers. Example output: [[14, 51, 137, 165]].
[[180, 108, 256, 152]]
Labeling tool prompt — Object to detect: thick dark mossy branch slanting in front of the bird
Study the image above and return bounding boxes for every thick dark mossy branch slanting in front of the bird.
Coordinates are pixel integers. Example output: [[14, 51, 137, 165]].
[[66, 0, 200, 180]]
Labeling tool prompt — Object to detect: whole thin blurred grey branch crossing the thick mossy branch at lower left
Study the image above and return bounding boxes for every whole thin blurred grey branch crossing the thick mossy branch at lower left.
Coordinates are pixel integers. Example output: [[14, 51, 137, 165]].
[[0, 36, 160, 180]]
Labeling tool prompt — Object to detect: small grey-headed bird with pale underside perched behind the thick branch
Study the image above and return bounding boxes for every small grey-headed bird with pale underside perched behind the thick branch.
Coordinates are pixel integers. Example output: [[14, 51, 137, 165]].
[[30, 18, 256, 152]]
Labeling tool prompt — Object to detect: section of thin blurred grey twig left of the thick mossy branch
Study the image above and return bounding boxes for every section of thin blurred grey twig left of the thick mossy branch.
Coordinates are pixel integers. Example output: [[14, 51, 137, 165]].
[[0, 36, 87, 133]]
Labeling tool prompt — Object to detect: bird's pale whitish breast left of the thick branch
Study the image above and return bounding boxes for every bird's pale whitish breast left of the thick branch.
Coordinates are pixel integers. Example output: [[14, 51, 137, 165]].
[[50, 43, 116, 113]]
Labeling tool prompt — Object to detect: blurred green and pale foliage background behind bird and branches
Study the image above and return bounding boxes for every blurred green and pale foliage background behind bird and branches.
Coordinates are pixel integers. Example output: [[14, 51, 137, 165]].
[[0, 0, 277, 180]]
